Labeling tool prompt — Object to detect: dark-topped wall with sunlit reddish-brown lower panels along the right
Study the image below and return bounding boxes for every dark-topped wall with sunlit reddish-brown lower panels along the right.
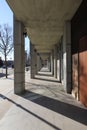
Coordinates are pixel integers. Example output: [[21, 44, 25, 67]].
[[71, 0, 87, 107]]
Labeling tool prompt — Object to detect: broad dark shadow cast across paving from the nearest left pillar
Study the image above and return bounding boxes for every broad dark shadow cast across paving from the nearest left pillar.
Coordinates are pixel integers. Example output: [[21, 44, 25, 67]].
[[21, 90, 87, 125]]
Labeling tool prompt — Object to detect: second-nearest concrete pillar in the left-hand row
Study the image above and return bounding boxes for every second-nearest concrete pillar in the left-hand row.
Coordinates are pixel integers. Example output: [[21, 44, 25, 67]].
[[30, 43, 35, 79]]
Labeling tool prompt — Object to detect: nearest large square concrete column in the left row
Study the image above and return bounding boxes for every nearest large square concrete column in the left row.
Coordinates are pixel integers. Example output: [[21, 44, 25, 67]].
[[14, 17, 25, 94]]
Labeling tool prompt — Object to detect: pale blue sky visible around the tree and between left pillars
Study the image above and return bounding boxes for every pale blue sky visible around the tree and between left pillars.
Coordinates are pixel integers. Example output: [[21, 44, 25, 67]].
[[0, 0, 30, 60]]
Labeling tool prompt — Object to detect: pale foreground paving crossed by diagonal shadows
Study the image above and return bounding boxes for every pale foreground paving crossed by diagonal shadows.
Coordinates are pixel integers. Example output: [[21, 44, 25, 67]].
[[0, 71, 87, 130]]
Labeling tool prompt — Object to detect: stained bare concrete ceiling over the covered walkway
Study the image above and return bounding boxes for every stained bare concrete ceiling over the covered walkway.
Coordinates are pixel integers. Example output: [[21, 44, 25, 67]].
[[6, 0, 82, 56]]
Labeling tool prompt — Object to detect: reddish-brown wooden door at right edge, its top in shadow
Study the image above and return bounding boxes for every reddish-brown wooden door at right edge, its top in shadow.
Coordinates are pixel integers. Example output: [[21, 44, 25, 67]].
[[79, 36, 87, 107]]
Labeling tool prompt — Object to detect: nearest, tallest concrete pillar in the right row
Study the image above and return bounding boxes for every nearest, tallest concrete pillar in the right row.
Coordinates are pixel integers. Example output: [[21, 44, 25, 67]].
[[63, 21, 71, 93]]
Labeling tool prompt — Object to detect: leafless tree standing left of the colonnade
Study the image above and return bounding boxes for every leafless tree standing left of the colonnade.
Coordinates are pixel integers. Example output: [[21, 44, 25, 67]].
[[0, 24, 13, 78]]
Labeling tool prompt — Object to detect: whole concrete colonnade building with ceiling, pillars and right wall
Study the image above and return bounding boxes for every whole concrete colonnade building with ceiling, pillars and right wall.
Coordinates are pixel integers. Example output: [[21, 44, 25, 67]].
[[7, 0, 87, 107]]
